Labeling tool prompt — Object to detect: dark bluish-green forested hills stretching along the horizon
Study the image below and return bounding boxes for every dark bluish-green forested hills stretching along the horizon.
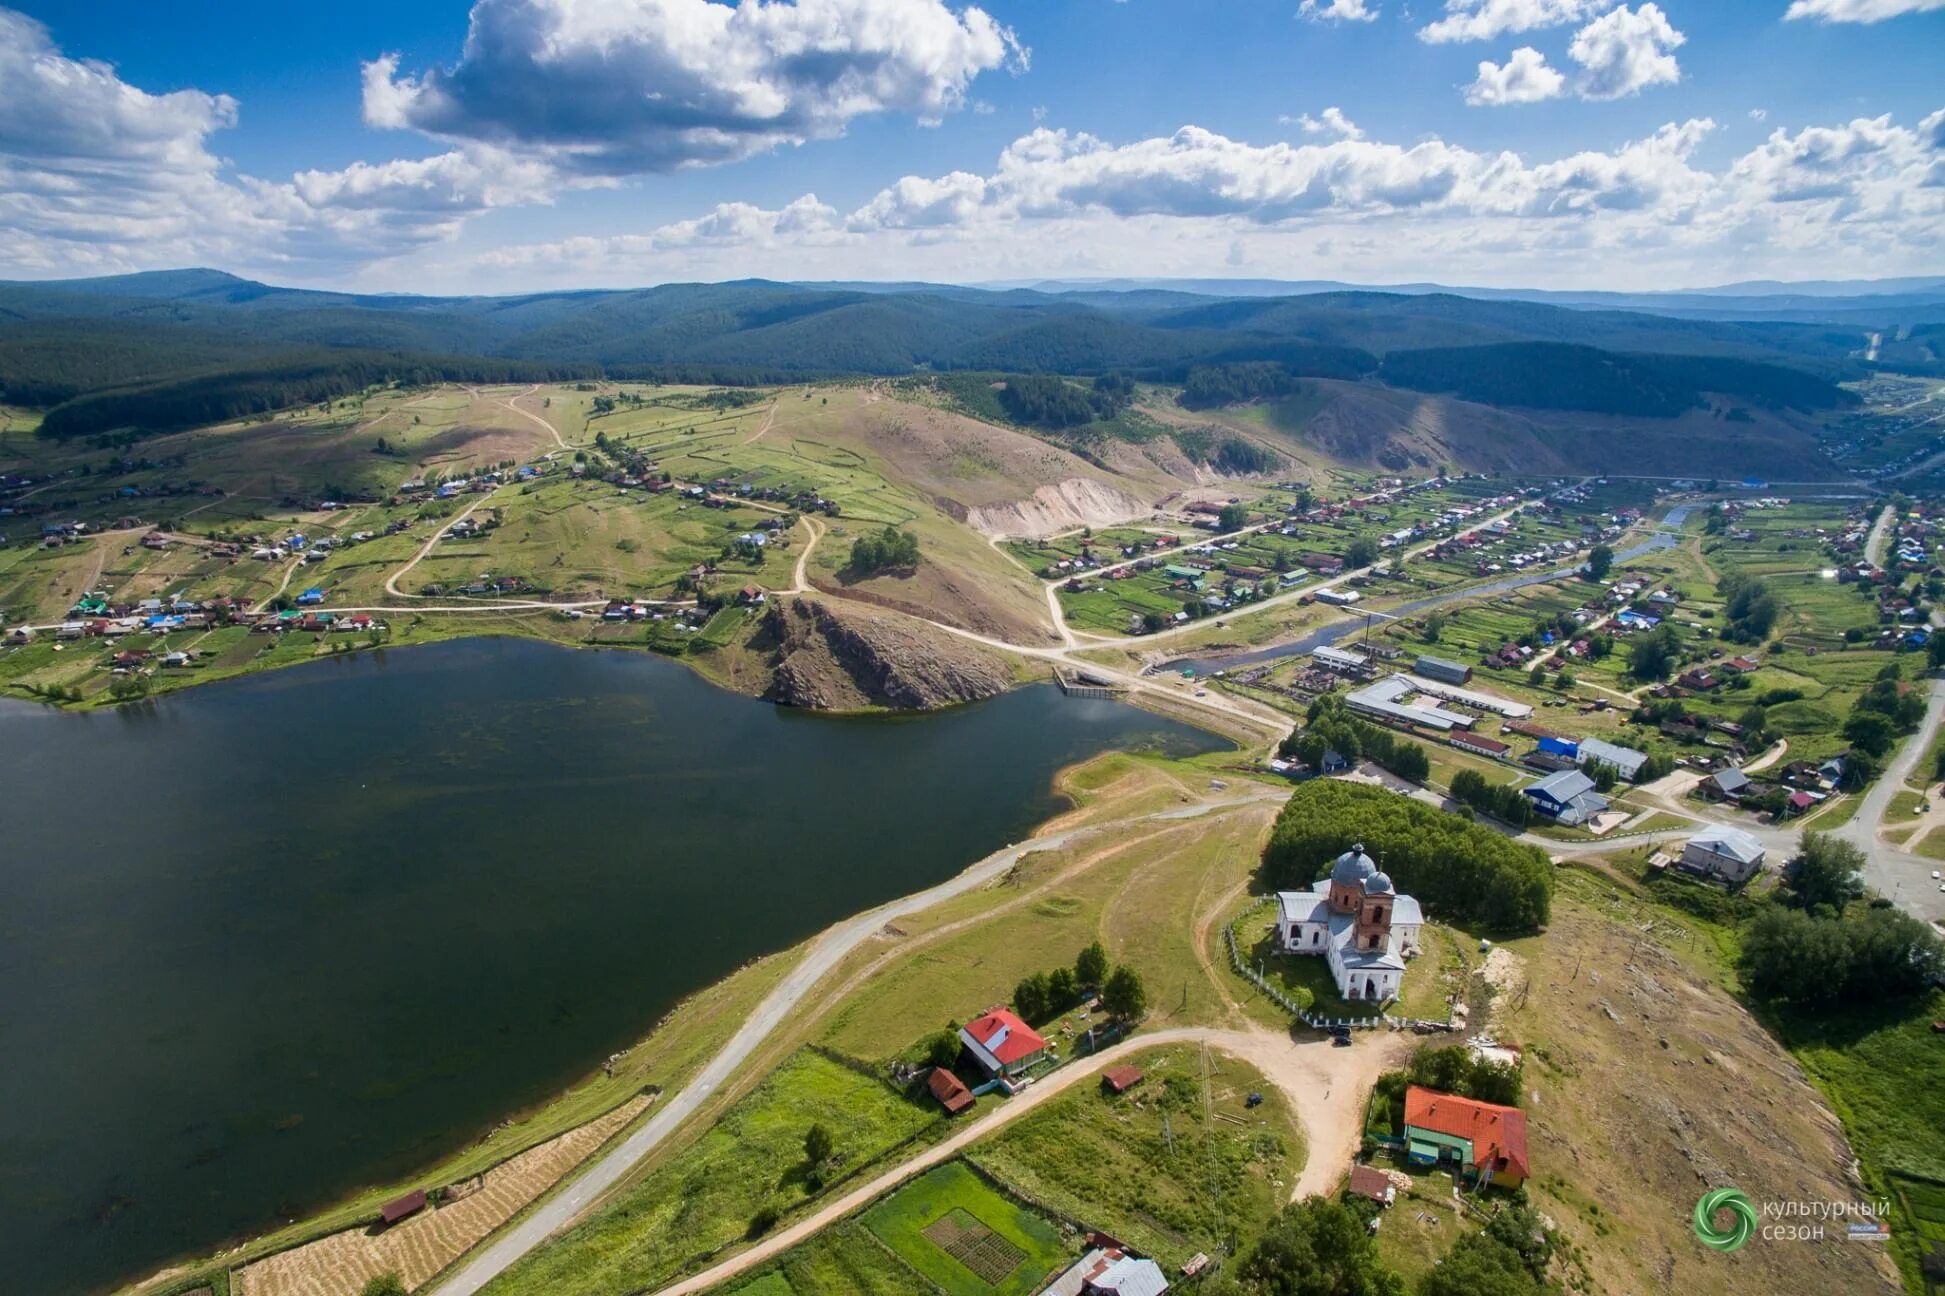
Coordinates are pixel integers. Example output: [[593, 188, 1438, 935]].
[[0, 270, 1906, 434]]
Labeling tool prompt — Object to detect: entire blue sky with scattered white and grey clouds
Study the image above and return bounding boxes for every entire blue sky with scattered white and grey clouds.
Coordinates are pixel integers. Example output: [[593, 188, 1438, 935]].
[[0, 0, 1945, 292]]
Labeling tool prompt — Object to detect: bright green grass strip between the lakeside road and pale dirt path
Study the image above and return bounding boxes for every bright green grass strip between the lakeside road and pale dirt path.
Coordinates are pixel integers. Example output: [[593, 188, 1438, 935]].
[[488, 1051, 939, 1296]]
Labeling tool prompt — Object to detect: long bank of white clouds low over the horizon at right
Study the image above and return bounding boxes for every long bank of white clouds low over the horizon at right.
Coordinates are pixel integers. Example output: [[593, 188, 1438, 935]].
[[470, 109, 1945, 286]]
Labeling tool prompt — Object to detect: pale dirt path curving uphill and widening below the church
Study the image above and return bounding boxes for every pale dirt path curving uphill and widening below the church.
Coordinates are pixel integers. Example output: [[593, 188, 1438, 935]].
[[659, 1027, 1410, 1296]]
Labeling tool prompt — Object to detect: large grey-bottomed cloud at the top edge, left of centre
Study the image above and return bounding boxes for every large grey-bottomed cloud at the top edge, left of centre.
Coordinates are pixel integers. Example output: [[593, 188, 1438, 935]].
[[364, 0, 1029, 175]]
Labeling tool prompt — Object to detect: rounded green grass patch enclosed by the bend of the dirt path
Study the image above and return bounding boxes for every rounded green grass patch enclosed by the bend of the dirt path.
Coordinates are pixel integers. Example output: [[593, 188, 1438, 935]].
[[971, 1045, 1303, 1269]]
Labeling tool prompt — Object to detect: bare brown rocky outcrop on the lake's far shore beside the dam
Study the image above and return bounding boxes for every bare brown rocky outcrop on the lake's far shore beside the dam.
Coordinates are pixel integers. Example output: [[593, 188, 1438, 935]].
[[764, 597, 1013, 710]]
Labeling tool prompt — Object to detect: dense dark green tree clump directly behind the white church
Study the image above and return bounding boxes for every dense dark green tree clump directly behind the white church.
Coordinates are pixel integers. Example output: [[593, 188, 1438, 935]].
[[1262, 778, 1554, 932]]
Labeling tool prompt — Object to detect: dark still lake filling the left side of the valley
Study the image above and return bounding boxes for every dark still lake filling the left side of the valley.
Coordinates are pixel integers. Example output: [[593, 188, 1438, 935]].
[[0, 638, 1225, 1294]]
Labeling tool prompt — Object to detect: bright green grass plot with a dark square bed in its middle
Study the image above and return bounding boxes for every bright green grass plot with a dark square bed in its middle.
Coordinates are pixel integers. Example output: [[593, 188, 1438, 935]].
[[862, 1162, 1072, 1296]]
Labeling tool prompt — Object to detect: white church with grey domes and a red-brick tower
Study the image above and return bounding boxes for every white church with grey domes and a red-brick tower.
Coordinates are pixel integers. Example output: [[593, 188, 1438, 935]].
[[1276, 845, 1424, 1004]]
